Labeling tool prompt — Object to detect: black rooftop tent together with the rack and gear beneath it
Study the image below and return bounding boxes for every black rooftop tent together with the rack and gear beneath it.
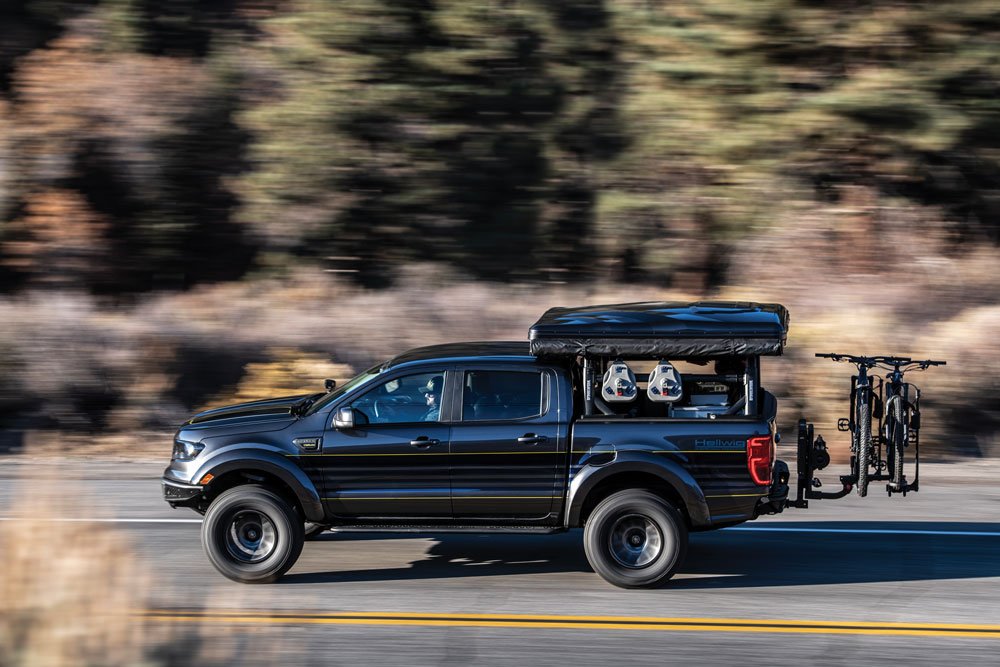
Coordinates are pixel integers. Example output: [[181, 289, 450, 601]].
[[528, 301, 789, 420]]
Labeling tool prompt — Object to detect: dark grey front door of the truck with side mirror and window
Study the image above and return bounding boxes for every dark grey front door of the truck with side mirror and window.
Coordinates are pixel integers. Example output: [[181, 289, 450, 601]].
[[322, 370, 451, 520]]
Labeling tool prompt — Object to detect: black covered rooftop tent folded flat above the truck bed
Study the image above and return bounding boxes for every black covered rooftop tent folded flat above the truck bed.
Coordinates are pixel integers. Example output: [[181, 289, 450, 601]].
[[528, 301, 788, 359]]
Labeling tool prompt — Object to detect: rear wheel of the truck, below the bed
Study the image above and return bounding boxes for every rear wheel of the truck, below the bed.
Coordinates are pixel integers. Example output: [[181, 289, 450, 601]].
[[583, 490, 687, 588]]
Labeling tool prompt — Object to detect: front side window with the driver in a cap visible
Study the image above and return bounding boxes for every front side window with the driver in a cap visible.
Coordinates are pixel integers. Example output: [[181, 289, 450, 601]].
[[351, 371, 444, 425]]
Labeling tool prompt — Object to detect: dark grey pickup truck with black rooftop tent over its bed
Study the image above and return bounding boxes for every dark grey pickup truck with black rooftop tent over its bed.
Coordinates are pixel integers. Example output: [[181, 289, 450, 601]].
[[162, 302, 788, 587]]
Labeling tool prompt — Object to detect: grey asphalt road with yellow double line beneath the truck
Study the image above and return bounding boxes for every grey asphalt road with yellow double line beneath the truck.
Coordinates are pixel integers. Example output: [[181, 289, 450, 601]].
[[0, 458, 1000, 665]]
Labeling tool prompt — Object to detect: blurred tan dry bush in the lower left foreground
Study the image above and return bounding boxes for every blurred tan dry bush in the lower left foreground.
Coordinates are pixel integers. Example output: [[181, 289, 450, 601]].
[[0, 479, 254, 667]]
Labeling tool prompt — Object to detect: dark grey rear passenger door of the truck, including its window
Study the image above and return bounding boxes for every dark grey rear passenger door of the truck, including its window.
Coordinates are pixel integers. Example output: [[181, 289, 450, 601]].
[[451, 366, 565, 521]]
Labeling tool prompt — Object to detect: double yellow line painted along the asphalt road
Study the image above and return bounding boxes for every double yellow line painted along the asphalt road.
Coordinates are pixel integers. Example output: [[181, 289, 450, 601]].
[[140, 609, 1000, 639]]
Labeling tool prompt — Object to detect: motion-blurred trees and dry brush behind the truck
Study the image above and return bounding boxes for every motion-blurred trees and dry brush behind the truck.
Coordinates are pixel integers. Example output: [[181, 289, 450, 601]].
[[0, 0, 1000, 456]]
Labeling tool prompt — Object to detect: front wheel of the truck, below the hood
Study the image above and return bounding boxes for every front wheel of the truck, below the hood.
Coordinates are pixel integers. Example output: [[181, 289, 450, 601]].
[[201, 485, 304, 584]]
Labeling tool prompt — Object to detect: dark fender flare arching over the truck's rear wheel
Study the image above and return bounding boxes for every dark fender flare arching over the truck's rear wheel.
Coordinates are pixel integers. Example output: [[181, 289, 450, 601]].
[[564, 451, 712, 527]]
